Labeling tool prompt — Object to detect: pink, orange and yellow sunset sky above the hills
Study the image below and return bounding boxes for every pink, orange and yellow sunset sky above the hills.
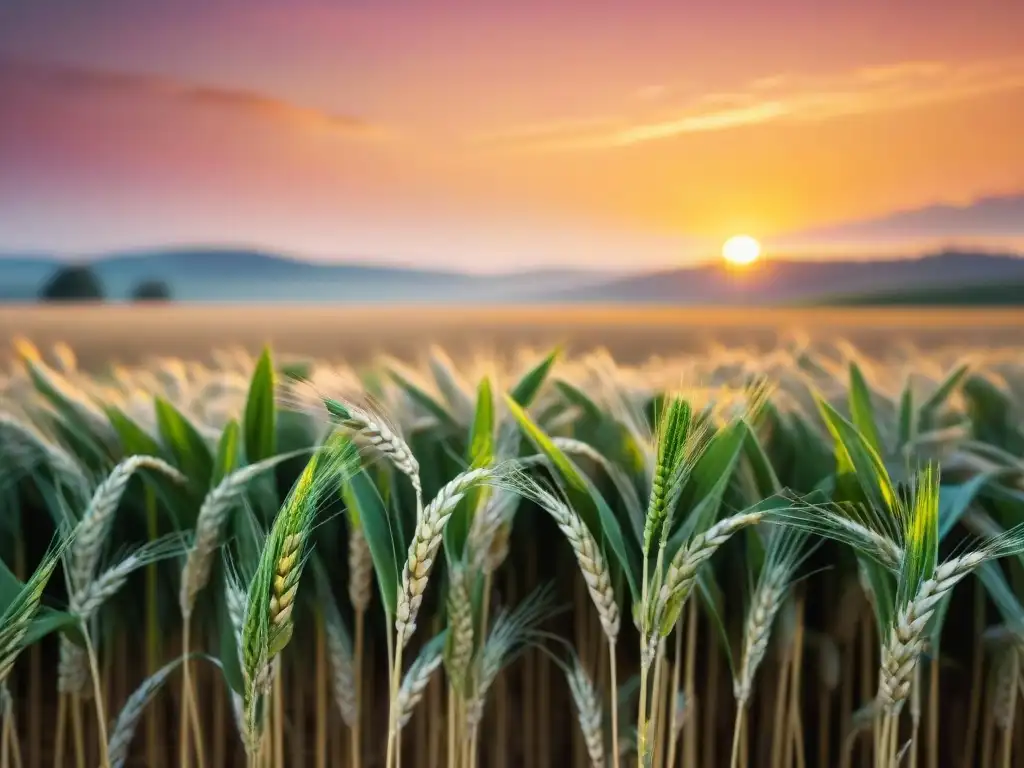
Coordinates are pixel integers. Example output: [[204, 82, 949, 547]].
[[0, 0, 1024, 271]]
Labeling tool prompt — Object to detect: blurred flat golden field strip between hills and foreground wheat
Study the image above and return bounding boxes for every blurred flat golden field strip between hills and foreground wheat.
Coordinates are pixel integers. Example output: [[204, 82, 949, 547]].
[[0, 304, 1024, 368]]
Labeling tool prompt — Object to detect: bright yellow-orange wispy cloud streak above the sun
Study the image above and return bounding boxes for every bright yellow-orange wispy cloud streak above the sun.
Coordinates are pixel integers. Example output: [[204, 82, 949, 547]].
[[478, 56, 1024, 152]]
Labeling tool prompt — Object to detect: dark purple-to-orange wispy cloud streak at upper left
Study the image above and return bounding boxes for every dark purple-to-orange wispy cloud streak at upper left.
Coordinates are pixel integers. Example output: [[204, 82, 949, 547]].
[[0, 57, 385, 138]]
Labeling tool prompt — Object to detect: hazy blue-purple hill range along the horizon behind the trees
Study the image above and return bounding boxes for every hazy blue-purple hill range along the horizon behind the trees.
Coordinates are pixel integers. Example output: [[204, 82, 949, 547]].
[[0, 248, 1024, 305]]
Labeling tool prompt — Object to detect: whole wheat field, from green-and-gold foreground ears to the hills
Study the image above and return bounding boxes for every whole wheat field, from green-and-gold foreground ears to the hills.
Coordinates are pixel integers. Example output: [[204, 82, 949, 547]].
[[0, 307, 1024, 768]]
